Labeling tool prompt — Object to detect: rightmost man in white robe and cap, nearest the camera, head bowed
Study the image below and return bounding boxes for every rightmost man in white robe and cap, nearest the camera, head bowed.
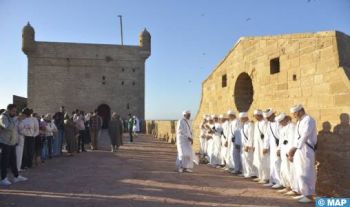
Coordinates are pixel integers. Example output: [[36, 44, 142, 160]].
[[288, 104, 317, 203]]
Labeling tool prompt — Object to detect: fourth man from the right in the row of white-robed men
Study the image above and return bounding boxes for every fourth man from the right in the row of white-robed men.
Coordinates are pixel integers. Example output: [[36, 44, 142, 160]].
[[253, 109, 270, 184]]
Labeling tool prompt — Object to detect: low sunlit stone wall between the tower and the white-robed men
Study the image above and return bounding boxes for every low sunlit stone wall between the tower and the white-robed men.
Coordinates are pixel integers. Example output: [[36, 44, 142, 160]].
[[145, 120, 177, 144]]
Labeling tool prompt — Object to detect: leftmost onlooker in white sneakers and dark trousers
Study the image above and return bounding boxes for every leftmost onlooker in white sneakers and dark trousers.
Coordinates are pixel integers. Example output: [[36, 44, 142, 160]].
[[0, 104, 28, 186]]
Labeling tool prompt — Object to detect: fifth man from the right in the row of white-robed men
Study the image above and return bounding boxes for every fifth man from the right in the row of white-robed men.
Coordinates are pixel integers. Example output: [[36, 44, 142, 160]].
[[239, 112, 255, 178]]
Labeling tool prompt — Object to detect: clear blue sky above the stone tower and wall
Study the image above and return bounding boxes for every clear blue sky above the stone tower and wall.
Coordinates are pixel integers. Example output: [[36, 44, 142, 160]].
[[0, 0, 350, 119]]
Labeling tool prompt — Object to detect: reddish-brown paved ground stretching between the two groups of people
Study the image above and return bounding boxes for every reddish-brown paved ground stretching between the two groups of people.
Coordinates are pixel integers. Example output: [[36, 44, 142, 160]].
[[0, 135, 314, 207]]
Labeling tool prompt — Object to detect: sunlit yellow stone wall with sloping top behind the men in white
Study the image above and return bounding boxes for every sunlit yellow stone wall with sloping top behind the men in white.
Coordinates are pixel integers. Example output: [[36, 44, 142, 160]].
[[193, 31, 350, 196]]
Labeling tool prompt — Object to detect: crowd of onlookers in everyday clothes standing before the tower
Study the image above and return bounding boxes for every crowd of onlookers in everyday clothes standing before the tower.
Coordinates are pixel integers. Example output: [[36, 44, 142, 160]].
[[0, 104, 140, 186]]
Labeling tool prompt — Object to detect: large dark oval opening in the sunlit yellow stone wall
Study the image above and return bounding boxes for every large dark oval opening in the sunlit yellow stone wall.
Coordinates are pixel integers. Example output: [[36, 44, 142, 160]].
[[233, 73, 254, 112]]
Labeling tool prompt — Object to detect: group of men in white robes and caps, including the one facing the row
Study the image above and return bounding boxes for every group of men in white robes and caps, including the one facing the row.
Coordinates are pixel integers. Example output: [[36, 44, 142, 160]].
[[176, 105, 317, 203]]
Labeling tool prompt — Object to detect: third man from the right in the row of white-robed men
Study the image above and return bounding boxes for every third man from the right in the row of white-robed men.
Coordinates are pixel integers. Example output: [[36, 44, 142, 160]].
[[263, 108, 282, 189]]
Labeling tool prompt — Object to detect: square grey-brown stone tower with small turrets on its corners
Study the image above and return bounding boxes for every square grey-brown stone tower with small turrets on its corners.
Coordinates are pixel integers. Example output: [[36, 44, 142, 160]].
[[22, 23, 151, 123]]
